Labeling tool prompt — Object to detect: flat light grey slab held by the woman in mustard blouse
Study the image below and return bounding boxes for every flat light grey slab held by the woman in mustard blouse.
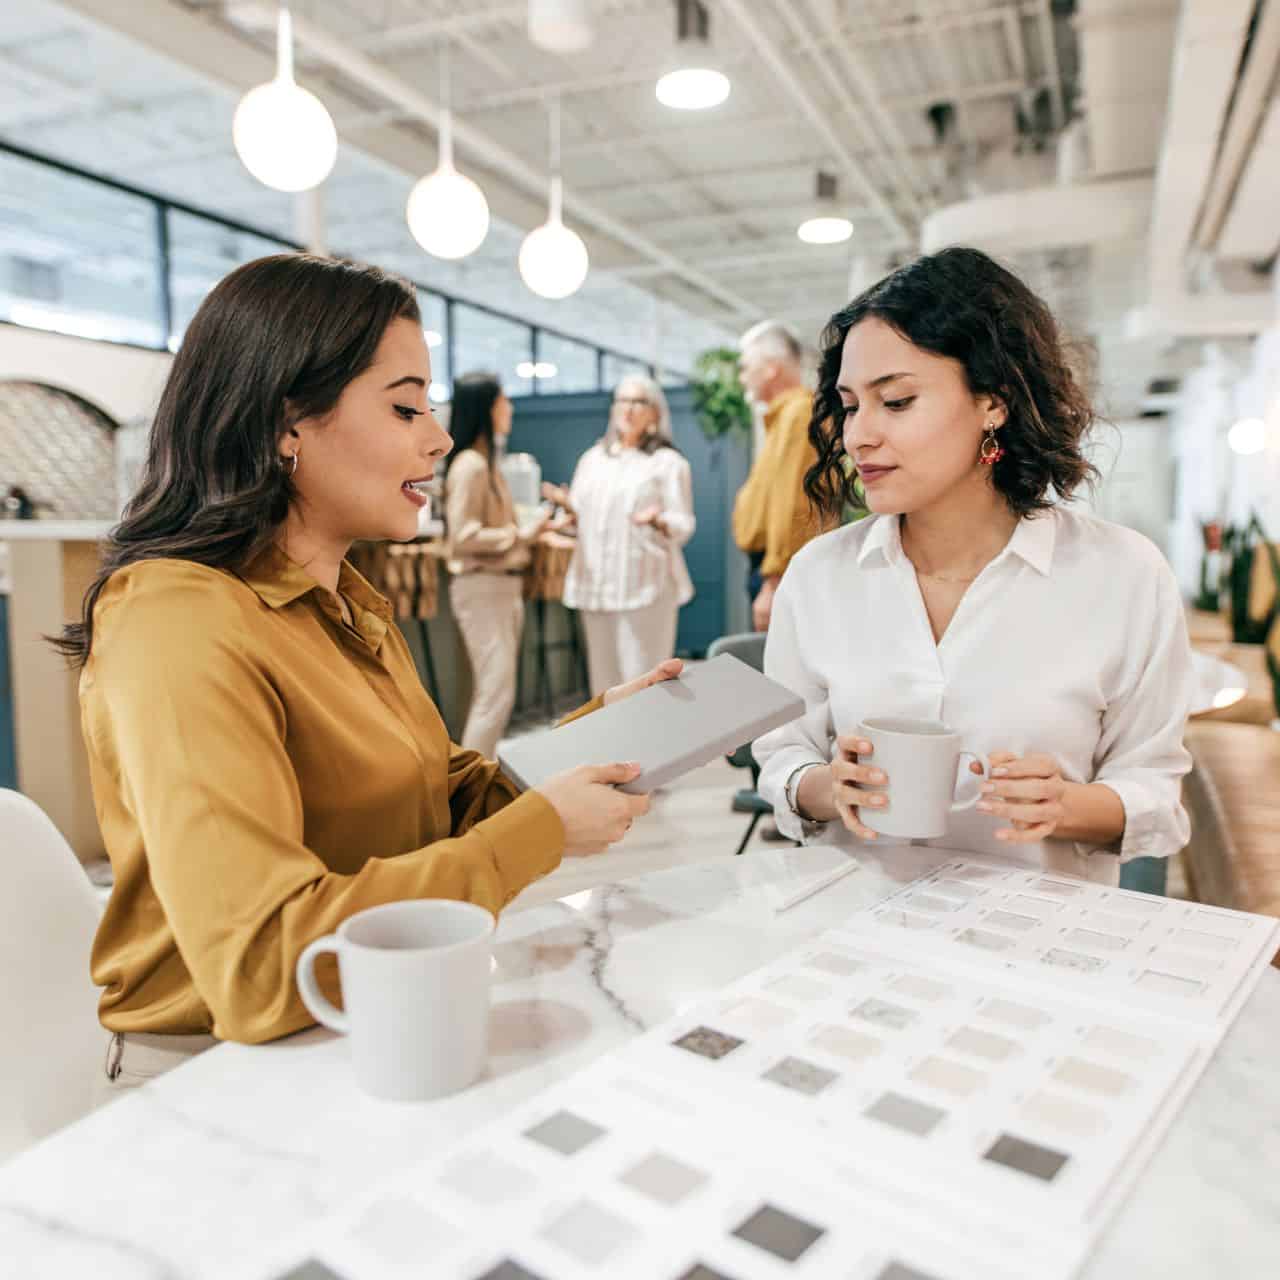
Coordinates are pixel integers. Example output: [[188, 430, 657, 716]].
[[498, 653, 804, 795]]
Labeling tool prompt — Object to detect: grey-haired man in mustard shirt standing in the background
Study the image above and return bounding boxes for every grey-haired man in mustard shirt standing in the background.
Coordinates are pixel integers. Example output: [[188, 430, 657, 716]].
[[733, 320, 822, 631]]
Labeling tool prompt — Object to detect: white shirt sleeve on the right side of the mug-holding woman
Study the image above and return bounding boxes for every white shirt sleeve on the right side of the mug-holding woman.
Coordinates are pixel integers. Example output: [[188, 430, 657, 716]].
[[1093, 561, 1194, 861]]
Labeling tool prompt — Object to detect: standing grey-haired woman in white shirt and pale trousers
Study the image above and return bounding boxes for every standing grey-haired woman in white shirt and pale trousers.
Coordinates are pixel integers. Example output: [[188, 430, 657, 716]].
[[545, 376, 696, 690]]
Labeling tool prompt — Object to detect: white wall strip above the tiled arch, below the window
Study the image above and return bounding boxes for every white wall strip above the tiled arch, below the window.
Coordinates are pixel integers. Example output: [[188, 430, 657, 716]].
[[0, 325, 173, 424]]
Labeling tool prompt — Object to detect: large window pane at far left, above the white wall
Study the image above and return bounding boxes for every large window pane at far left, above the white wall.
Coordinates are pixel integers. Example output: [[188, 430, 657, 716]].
[[0, 151, 165, 347]]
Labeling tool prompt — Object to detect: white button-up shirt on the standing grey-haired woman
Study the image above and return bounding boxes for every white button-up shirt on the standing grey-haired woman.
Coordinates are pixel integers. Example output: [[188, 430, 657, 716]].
[[564, 444, 696, 612]]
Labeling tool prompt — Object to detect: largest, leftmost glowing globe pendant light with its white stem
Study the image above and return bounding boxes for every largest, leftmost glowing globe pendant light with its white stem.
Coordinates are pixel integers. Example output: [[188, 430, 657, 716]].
[[232, 4, 338, 191]]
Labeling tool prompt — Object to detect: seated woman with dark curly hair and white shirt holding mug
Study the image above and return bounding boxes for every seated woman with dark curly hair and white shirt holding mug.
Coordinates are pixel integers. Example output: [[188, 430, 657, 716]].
[[755, 248, 1192, 884]]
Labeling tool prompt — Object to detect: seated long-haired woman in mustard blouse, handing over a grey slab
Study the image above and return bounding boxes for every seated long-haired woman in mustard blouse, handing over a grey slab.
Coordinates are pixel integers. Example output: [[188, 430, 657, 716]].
[[61, 253, 680, 1085]]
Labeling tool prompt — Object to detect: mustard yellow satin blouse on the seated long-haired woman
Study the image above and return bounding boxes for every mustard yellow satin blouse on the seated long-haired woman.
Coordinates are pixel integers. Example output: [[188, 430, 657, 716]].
[[79, 550, 581, 1042]]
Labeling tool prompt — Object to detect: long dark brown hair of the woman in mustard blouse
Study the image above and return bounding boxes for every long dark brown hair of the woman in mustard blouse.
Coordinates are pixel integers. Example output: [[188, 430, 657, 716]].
[[52, 253, 420, 666]]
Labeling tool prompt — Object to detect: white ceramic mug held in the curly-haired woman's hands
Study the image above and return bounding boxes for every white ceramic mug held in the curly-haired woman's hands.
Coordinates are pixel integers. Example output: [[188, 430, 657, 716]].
[[858, 716, 991, 840]]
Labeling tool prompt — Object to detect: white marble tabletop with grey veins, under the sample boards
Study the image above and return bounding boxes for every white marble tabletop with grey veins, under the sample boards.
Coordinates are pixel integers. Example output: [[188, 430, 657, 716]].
[[0, 847, 1280, 1280]]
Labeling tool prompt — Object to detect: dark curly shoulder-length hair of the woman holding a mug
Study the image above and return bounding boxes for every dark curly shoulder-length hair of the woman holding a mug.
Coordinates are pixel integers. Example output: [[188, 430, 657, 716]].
[[804, 248, 1097, 517]]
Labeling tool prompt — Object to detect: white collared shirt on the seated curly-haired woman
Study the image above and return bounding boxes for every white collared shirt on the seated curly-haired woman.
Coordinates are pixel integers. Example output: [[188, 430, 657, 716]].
[[755, 506, 1194, 884]]
